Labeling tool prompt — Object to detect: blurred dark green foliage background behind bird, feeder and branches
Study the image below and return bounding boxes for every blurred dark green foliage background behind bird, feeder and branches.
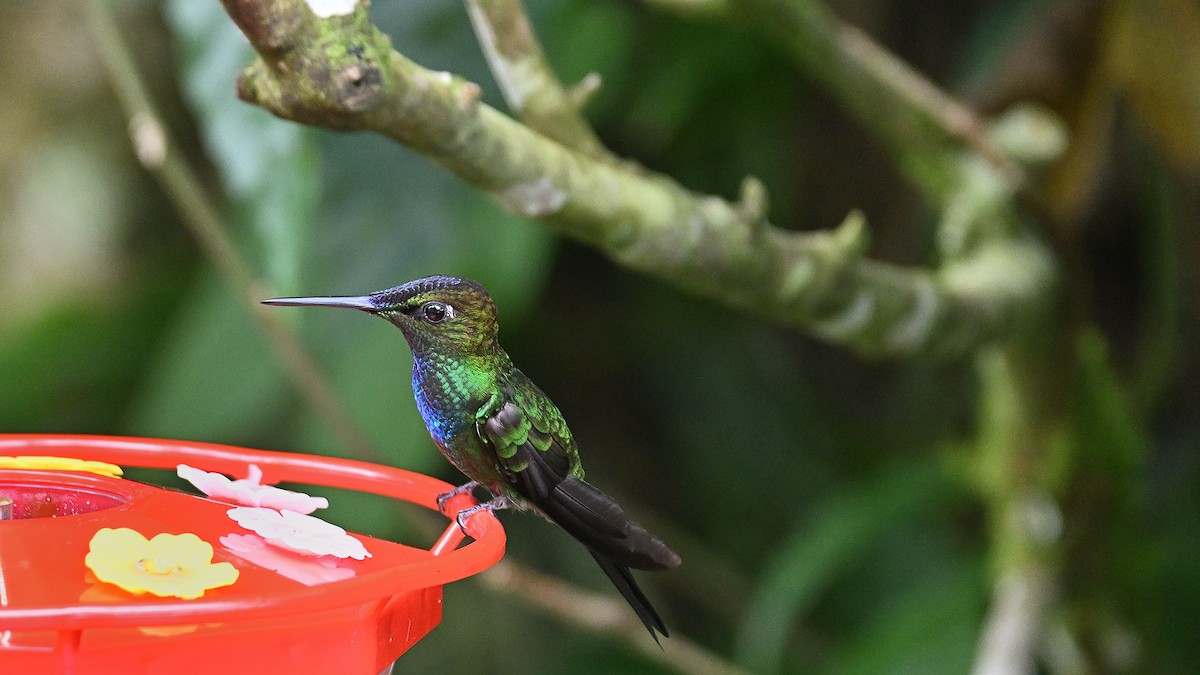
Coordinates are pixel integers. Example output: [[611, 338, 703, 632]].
[[0, 0, 1200, 673]]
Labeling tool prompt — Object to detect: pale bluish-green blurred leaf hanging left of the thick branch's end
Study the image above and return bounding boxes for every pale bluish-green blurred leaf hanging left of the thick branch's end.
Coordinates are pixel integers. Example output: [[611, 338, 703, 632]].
[[166, 0, 320, 288]]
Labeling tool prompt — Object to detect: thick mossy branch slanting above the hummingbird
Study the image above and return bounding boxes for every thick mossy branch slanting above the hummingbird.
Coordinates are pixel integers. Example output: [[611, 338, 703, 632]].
[[222, 0, 1045, 356]]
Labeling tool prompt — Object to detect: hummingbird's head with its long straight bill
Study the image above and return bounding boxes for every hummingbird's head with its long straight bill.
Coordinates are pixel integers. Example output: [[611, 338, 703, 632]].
[[263, 276, 498, 356]]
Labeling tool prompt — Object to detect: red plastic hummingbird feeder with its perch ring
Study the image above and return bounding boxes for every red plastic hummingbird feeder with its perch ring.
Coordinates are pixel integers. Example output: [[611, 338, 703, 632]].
[[0, 435, 504, 675]]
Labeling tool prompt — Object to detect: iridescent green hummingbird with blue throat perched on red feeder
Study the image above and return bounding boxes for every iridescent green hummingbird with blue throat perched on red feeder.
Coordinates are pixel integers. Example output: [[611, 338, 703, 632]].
[[263, 271, 680, 641]]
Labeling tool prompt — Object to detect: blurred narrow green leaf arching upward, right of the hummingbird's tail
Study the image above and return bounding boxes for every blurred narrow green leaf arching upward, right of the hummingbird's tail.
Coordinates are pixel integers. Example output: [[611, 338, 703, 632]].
[[737, 460, 948, 673]]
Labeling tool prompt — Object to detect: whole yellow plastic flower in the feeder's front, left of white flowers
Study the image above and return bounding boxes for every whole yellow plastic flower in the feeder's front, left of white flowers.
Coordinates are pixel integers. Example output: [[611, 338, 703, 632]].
[[84, 527, 238, 599]]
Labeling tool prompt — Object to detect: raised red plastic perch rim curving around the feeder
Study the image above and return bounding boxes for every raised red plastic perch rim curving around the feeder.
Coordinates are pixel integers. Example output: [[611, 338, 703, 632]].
[[0, 434, 505, 631]]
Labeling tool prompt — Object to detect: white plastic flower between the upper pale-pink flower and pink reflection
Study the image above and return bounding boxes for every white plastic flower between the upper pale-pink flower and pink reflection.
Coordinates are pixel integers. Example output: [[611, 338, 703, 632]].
[[227, 507, 371, 560]]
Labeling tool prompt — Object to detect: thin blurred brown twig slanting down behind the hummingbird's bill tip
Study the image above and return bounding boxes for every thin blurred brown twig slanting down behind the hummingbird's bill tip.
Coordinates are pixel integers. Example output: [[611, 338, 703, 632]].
[[83, 0, 382, 460]]
